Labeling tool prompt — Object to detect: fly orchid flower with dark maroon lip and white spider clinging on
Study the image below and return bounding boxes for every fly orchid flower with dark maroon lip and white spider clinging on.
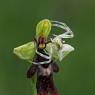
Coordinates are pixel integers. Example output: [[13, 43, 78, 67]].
[[13, 19, 74, 95]]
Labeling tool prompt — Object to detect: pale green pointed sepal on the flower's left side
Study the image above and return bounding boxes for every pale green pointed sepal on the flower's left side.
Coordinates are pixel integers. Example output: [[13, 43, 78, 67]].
[[13, 41, 36, 63]]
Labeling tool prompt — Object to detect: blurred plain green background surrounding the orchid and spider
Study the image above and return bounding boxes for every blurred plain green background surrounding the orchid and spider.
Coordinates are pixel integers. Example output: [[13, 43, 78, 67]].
[[0, 0, 95, 95]]
